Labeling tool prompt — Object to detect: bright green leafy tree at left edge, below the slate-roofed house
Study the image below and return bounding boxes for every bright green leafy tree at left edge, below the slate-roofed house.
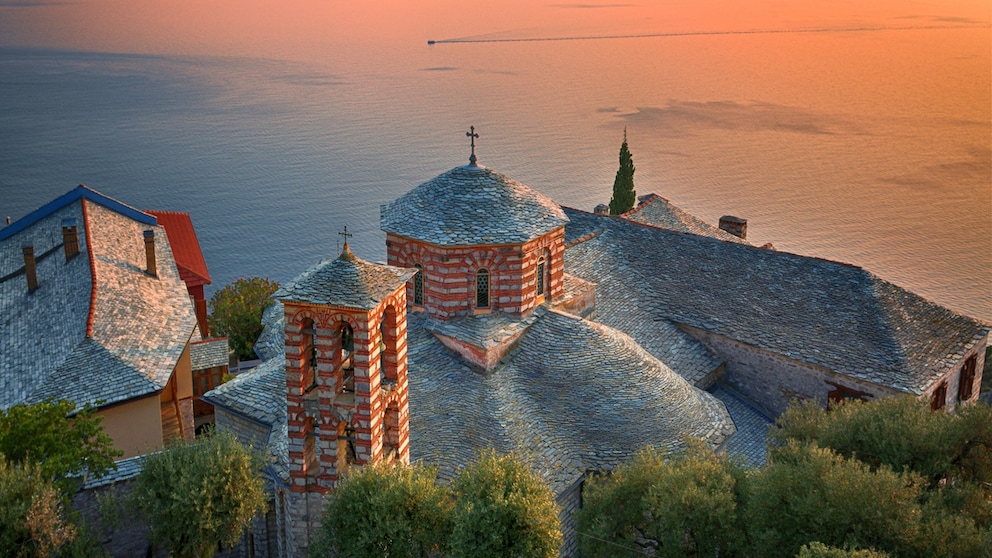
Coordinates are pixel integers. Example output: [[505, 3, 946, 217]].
[[0, 399, 123, 495]]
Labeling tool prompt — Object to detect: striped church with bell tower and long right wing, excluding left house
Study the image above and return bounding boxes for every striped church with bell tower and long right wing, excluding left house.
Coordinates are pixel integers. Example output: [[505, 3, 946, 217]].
[[205, 147, 989, 556]]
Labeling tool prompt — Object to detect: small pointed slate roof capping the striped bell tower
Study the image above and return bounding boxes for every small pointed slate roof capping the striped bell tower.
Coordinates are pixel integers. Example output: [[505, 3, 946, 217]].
[[272, 244, 417, 310]]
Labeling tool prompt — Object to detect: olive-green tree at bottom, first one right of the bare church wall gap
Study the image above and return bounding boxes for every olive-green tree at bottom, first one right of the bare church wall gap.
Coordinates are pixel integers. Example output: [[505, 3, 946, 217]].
[[578, 440, 745, 558]]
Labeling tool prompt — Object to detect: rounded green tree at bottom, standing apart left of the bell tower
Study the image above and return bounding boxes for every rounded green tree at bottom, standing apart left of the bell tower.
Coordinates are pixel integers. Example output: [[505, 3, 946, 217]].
[[132, 432, 265, 557]]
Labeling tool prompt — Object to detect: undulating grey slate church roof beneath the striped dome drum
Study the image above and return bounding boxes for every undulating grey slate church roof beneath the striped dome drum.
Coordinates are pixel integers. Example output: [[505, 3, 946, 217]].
[[211, 304, 734, 493]]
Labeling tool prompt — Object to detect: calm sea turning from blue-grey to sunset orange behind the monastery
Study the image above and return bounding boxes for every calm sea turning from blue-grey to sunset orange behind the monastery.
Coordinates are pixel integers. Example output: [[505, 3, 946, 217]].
[[0, 2, 992, 321]]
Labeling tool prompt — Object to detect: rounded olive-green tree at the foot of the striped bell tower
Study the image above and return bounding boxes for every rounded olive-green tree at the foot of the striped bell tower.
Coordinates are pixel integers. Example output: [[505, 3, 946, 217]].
[[309, 463, 451, 558]]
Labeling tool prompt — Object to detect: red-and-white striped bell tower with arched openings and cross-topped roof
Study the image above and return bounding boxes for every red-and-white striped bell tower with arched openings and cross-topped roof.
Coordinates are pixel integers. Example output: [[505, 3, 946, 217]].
[[274, 243, 416, 496]]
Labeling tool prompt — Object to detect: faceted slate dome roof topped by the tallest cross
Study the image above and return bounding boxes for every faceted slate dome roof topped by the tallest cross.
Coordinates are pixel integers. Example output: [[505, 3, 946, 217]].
[[380, 165, 568, 246]]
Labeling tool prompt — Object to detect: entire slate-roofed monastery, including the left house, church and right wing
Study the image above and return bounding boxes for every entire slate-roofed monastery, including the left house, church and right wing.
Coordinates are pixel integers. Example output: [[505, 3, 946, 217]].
[[0, 138, 990, 557]]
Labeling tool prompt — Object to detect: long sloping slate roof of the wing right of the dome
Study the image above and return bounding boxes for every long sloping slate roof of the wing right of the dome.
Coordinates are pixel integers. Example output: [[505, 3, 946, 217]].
[[565, 209, 989, 395]]
